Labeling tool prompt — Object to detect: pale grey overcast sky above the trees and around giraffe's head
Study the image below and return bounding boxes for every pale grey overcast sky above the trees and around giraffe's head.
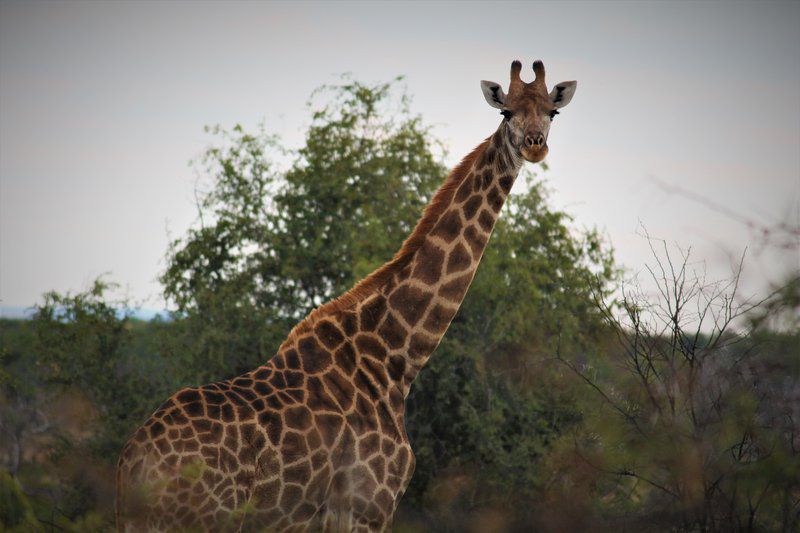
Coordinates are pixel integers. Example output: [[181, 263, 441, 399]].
[[0, 1, 800, 309]]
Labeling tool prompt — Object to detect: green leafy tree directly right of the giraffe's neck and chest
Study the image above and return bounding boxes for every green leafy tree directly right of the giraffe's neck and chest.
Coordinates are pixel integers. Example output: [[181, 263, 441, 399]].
[[401, 171, 617, 530]]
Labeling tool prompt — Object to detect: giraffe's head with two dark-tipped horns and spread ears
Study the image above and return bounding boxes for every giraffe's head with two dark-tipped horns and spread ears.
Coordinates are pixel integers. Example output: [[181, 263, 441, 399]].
[[481, 60, 578, 163]]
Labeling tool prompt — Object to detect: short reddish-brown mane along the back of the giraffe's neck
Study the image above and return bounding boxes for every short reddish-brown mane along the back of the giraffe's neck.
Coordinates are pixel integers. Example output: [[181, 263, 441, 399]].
[[281, 137, 491, 342]]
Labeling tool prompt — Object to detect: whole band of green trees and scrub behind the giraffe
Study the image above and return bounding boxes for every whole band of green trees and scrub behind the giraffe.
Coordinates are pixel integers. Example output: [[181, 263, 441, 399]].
[[0, 79, 800, 531]]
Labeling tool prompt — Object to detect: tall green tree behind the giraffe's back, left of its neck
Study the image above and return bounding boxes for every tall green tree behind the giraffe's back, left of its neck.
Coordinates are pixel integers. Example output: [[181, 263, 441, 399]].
[[162, 82, 445, 380]]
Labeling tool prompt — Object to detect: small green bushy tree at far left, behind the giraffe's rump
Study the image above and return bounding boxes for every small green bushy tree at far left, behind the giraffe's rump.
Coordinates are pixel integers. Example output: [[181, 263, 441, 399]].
[[32, 279, 171, 457]]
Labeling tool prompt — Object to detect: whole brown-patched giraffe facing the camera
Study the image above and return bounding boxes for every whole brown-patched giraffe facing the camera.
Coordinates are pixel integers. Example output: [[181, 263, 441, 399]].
[[116, 61, 577, 531]]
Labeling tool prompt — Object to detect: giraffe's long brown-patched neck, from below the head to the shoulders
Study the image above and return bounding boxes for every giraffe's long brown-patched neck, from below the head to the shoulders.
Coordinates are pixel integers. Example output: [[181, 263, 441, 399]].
[[282, 123, 522, 406]]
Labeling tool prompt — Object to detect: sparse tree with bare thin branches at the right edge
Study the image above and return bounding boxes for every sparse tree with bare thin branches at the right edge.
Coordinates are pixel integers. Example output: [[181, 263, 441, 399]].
[[557, 241, 800, 531]]
